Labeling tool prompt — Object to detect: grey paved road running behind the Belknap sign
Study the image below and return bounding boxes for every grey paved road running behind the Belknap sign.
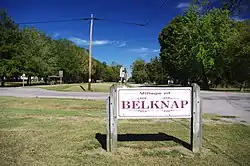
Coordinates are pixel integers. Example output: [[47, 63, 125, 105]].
[[0, 88, 250, 123]]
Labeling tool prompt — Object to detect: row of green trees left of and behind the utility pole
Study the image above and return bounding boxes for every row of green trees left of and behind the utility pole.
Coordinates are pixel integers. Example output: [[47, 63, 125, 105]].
[[0, 10, 121, 86]]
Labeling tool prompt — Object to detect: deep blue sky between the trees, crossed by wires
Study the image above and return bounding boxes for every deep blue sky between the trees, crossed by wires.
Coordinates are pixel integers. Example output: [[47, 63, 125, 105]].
[[0, 0, 248, 73]]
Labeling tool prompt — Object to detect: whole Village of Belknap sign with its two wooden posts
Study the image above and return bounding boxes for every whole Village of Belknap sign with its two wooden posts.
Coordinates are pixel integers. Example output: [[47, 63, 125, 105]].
[[106, 84, 202, 153]]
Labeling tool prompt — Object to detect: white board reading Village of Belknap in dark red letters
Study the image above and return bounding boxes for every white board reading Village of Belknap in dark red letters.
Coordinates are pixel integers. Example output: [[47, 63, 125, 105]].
[[117, 87, 192, 119]]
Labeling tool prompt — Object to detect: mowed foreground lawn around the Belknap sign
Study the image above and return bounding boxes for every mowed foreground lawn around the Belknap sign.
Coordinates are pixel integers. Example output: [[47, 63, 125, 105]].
[[0, 97, 250, 166]]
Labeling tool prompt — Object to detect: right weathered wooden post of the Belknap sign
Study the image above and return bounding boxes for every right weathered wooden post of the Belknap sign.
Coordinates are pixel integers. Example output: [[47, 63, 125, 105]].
[[191, 84, 202, 153]]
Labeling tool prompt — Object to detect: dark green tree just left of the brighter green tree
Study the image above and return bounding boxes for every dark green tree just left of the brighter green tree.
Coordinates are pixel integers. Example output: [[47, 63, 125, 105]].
[[158, 11, 199, 84]]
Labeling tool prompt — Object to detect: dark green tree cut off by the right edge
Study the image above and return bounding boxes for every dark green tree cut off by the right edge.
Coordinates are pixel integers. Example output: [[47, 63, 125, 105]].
[[223, 21, 250, 91]]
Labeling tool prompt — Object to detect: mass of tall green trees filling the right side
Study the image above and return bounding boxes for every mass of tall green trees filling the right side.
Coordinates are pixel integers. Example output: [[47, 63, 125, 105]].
[[132, 2, 250, 89]]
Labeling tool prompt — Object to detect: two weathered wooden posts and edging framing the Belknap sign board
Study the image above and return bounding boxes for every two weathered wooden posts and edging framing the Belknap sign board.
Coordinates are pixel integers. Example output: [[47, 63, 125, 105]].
[[106, 83, 202, 153]]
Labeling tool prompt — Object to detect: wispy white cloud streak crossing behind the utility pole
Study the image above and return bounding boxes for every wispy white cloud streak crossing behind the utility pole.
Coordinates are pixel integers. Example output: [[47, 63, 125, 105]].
[[68, 37, 127, 47]]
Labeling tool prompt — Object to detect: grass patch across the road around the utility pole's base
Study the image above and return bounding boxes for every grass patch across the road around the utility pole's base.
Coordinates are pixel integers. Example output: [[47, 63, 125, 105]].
[[36, 83, 116, 92]]
